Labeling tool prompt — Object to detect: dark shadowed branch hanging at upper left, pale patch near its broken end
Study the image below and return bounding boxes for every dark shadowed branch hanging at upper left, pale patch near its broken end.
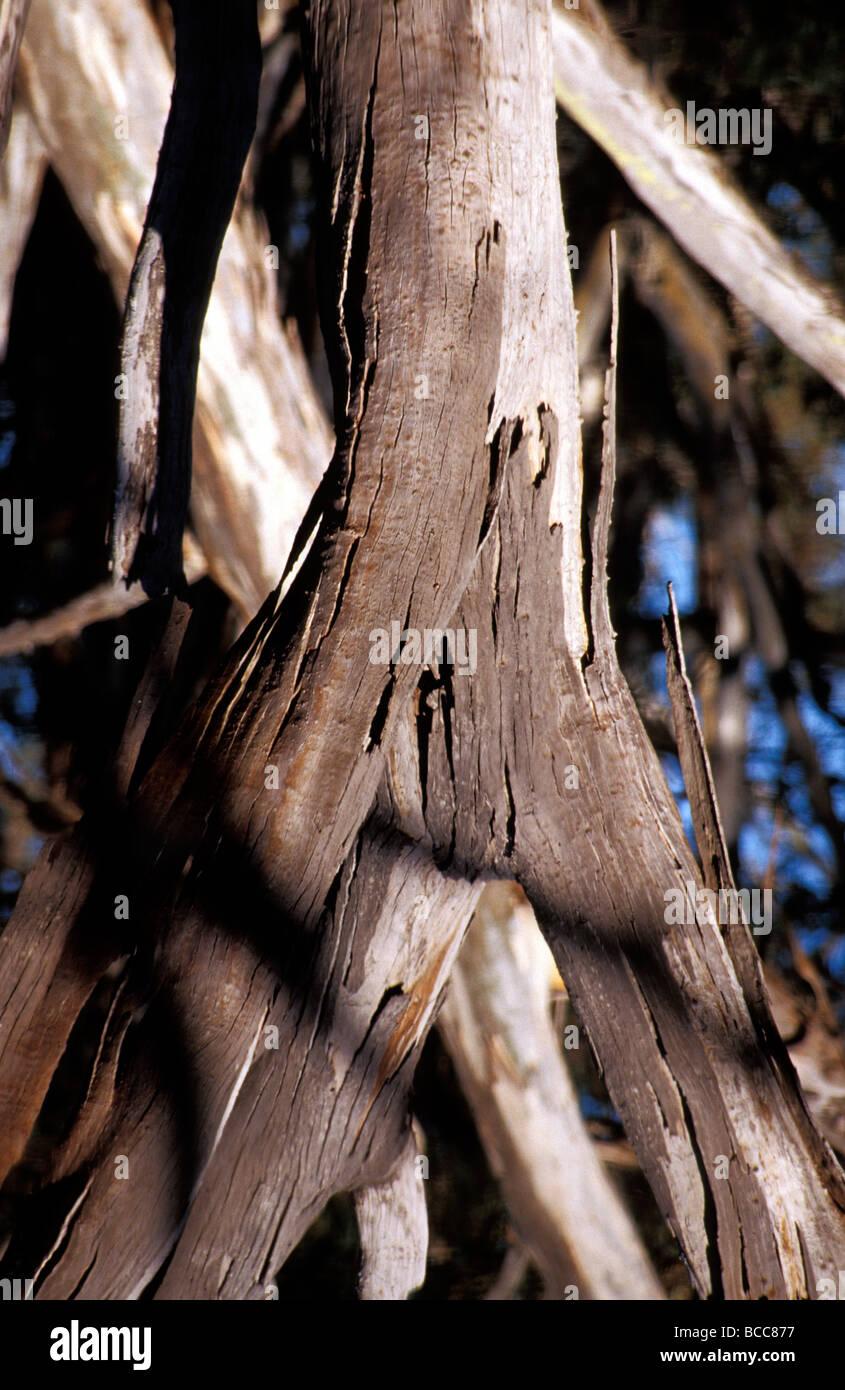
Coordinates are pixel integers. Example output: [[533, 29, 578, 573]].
[[111, 0, 261, 595]]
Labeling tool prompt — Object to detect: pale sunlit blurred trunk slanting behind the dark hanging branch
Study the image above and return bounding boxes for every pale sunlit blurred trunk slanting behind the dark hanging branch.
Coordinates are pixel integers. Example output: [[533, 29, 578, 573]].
[[19, 0, 332, 621]]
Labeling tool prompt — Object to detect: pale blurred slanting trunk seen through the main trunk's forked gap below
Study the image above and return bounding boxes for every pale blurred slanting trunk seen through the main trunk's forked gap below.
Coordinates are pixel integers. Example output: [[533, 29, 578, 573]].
[[439, 884, 663, 1300]]
